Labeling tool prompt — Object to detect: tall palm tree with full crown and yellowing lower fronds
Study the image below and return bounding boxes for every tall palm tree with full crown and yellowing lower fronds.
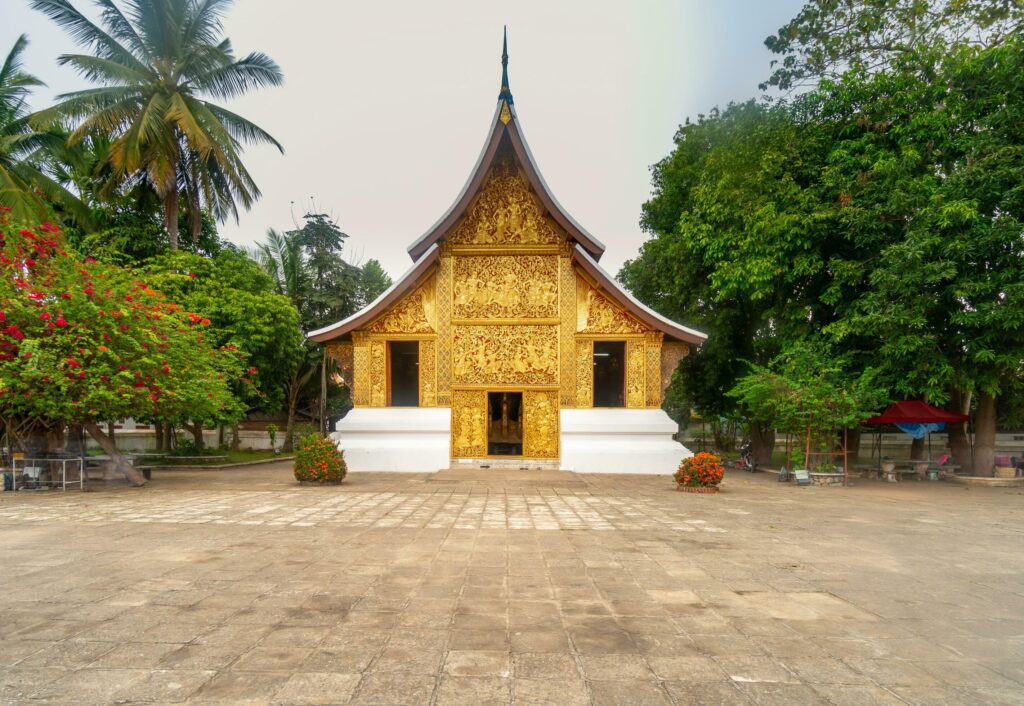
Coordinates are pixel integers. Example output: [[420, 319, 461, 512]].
[[32, 0, 284, 250]]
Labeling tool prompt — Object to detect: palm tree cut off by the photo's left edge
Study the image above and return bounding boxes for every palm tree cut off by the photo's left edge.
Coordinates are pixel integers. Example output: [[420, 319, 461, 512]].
[[0, 35, 87, 219]]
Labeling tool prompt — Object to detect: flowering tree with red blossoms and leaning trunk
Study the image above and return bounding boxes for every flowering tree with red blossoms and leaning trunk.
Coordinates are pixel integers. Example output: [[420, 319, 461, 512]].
[[0, 213, 252, 485]]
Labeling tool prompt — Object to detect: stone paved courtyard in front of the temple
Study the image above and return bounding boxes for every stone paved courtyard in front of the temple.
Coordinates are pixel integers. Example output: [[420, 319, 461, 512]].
[[0, 464, 1024, 706]]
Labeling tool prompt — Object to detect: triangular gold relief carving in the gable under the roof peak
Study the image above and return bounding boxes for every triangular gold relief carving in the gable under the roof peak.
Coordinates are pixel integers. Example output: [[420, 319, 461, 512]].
[[449, 160, 565, 245]]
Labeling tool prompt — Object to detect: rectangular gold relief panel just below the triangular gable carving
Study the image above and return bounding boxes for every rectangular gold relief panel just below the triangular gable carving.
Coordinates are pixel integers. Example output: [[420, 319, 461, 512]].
[[452, 255, 558, 319]]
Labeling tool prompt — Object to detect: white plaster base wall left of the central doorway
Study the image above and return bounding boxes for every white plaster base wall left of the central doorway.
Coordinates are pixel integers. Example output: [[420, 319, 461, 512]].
[[331, 407, 452, 472]]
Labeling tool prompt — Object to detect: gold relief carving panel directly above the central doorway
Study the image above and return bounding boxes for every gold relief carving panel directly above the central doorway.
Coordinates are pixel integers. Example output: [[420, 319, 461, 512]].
[[452, 326, 558, 385]]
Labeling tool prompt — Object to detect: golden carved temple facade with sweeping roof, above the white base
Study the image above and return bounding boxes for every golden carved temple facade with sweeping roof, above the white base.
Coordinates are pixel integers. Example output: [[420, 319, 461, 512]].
[[310, 33, 705, 459]]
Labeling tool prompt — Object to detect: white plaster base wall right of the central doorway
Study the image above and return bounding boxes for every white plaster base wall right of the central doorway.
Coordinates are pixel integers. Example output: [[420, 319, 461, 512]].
[[561, 409, 693, 473]]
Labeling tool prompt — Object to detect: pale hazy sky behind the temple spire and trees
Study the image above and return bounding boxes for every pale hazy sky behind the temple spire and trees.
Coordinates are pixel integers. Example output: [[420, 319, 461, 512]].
[[6, 0, 803, 278]]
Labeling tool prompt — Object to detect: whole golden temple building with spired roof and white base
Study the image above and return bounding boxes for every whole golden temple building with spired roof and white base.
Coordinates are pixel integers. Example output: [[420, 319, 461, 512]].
[[309, 35, 706, 473]]
